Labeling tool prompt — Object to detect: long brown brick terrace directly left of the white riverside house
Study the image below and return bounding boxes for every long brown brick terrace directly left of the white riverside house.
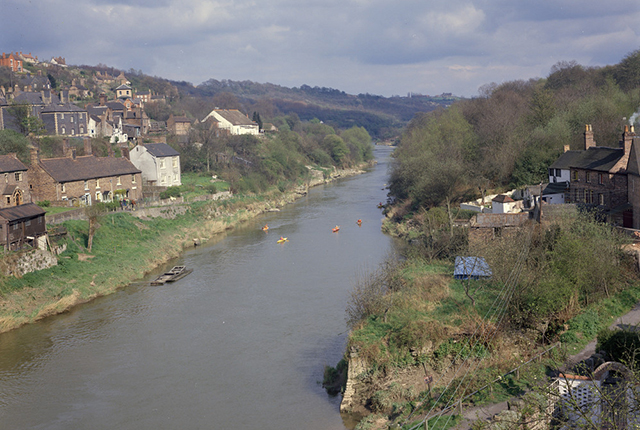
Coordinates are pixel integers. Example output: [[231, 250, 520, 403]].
[[29, 140, 142, 206]]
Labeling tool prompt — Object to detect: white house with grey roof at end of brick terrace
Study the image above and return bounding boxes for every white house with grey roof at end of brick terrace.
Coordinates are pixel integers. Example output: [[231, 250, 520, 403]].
[[129, 143, 182, 187]]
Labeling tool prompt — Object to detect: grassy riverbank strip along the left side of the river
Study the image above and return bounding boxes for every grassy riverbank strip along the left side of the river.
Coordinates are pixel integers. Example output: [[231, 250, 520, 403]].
[[0, 165, 367, 333]]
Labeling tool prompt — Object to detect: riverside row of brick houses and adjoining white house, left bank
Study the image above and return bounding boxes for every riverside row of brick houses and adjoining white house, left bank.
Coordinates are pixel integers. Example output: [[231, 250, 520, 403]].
[[0, 139, 181, 248]]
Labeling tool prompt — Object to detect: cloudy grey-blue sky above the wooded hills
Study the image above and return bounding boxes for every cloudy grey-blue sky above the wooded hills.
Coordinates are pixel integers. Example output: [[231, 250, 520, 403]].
[[0, 0, 640, 96]]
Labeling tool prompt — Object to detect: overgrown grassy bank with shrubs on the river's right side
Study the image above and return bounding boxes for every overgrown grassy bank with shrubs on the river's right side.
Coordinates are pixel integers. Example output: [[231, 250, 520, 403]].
[[336, 210, 640, 429]]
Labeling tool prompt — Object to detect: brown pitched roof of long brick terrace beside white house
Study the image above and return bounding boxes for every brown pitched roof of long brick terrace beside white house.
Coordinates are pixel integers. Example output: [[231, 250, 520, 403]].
[[40, 155, 141, 183]]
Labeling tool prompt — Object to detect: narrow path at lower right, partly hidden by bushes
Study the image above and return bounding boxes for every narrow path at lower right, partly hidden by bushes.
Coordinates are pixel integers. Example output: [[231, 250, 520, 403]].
[[456, 303, 640, 430]]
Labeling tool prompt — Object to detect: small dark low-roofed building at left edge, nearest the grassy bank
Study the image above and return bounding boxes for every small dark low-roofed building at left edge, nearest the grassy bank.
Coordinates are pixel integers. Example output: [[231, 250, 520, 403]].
[[0, 203, 47, 250]]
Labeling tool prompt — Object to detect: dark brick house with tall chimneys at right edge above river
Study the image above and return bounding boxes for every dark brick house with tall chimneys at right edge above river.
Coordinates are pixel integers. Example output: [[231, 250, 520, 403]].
[[549, 125, 640, 228]]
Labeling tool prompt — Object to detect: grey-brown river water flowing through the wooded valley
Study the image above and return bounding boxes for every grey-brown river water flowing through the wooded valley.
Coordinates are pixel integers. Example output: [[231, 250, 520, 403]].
[[0, 147, 394, 430]]
